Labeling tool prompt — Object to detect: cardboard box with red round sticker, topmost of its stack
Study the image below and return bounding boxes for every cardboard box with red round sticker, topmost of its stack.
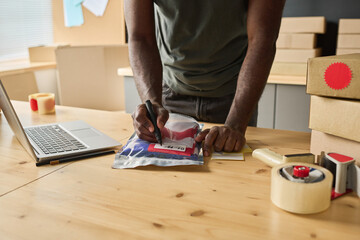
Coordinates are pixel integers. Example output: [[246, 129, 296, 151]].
[[306, 54, 360, 99]]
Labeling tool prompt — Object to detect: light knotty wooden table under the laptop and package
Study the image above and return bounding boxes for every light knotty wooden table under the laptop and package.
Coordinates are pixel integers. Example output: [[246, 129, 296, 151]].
[[0, 102, 360, 240]]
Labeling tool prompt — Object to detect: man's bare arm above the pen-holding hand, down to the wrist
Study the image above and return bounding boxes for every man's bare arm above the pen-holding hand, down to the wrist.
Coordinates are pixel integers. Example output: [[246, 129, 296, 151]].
[[124, 0, 162, 105]]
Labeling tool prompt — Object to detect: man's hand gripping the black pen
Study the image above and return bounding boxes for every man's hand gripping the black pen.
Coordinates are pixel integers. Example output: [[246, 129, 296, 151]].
[[132, 103, 169, 142]]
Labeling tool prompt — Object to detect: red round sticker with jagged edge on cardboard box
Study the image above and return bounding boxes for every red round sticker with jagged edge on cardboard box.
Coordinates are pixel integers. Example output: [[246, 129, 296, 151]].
[[324, 62, 352, 90]]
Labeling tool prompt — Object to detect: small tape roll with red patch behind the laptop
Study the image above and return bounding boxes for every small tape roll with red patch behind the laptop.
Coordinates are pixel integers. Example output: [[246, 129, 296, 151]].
[[29, 93, 55, 114]]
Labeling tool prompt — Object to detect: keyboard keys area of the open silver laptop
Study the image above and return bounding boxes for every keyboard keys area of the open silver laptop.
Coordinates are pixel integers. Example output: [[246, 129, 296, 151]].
[[25, 125, 86, 154]]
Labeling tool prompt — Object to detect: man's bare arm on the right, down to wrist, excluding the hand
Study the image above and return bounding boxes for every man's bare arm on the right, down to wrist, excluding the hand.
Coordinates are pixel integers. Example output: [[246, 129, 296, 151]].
[[225, 0, 285, 133]]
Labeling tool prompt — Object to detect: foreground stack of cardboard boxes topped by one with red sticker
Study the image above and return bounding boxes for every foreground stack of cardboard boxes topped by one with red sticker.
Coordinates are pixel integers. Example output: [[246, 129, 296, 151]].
[[307, 54, 360, 164]]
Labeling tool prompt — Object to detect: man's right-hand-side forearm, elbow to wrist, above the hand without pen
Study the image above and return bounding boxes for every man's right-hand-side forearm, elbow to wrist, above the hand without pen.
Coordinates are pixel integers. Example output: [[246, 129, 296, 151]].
[[225, 41, 276, 133]]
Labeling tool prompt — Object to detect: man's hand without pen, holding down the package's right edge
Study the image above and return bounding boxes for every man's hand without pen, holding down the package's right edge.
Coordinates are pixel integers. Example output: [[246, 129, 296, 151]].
[[195, 125, 246, 157]]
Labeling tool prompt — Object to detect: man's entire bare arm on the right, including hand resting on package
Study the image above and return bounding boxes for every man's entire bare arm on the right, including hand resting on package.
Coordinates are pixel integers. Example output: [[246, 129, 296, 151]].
[[196, 0, 285, 156]]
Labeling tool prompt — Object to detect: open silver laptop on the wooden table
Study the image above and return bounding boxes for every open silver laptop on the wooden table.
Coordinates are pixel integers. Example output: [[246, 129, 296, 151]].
[[0, 80, 121, 166]]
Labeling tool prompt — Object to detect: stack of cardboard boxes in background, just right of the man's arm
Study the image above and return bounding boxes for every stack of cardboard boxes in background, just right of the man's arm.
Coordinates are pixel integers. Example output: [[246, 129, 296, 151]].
[[270, 17, 326, 78]]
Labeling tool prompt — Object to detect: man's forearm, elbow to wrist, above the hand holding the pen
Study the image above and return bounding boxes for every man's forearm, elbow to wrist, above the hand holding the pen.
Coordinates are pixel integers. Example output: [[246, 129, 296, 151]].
[[129, 39, 162, 104]]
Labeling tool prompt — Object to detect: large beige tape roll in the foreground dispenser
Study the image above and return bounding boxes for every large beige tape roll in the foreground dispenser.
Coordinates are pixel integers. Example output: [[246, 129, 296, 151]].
[[271, 162, 333, 214]]
